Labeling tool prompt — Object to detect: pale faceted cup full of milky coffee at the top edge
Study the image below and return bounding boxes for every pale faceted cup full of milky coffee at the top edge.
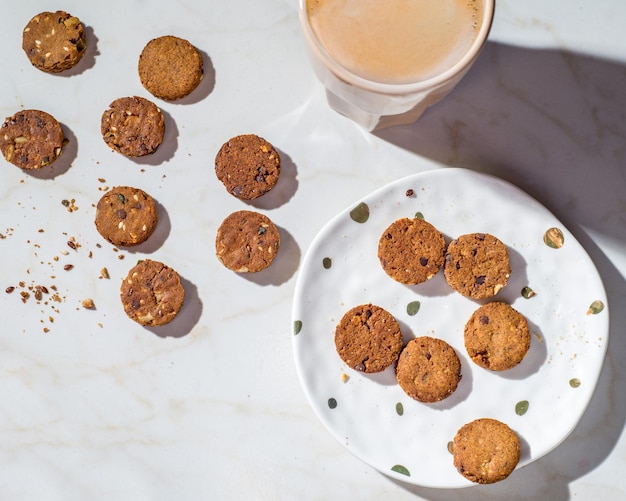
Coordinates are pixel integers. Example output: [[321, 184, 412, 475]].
[[299, 0, 495, 131]]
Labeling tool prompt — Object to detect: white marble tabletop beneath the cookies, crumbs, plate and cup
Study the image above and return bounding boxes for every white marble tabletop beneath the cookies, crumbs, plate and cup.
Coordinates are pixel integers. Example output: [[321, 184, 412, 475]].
[[0, 0, 626, 501]]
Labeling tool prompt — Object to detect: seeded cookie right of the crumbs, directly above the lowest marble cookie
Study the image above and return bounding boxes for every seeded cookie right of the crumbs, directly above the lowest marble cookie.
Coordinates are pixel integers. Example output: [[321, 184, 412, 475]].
[[95, 186, 159, 246]]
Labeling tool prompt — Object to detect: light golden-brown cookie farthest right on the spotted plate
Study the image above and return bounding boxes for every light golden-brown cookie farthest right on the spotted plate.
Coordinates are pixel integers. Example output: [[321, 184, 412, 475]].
[[464, 302, 530, 371]]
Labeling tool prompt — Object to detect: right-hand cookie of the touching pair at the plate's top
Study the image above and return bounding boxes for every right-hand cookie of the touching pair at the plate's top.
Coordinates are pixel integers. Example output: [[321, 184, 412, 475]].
[[443, 233, 511, 299]]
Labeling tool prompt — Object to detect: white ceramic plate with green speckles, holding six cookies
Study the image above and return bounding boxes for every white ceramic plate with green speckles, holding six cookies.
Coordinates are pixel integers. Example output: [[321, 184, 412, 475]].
[[293, 168, 608, 488]]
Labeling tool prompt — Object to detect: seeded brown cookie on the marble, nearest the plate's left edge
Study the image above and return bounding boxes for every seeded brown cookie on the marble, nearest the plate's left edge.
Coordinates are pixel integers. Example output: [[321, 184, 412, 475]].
[[215, 210, 280, 273]]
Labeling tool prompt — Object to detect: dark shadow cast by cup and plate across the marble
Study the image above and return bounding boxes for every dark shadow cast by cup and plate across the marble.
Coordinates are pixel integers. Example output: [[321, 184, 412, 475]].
[[376, 42, 626, 501]]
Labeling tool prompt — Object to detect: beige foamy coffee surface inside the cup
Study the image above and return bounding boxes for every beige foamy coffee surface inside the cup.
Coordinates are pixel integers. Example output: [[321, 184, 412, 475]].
[[307, 0, 483, 84]]
